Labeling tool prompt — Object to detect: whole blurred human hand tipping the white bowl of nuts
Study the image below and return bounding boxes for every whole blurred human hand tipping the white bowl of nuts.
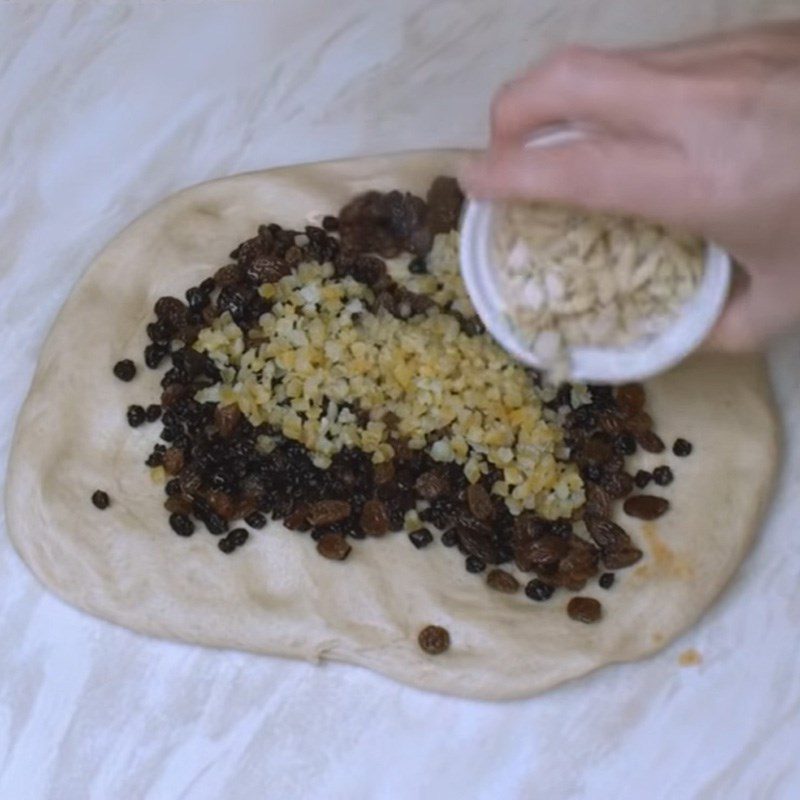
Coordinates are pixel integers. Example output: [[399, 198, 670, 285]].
[[461, 23, 800, 351]]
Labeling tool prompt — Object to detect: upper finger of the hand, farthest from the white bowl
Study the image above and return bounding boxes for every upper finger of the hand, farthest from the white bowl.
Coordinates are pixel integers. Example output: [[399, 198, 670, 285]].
[[492, 47, 677, 146]]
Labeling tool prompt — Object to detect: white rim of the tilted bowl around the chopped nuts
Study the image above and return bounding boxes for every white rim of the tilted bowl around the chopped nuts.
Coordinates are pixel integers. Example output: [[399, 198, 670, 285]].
[[460, 134, 731, 383]]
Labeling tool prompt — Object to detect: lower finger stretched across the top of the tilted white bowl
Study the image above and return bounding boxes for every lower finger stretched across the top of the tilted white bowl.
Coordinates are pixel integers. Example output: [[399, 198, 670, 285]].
[[460, 136, 697, 227]]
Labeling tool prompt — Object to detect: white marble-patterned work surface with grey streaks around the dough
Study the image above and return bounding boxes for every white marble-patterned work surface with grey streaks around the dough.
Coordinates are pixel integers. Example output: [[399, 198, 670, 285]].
[[0, 0, 800, 800]]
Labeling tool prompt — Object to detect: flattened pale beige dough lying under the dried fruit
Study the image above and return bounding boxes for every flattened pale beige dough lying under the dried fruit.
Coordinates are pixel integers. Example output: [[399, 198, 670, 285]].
[[6, 152, 778, 699]]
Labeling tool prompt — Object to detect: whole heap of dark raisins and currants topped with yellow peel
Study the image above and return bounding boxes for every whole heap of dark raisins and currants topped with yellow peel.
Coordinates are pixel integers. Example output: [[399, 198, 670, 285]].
[[109, 177, 691, 621]]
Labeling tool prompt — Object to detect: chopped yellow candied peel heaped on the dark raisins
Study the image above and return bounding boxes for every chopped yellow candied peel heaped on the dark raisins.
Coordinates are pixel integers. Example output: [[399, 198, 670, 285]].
[[195, 234, 584, 519]]
